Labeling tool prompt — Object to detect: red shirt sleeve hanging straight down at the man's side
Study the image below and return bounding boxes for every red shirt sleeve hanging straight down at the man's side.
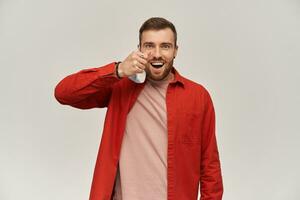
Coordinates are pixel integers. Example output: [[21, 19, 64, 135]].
[[200, 91, 223, 200]]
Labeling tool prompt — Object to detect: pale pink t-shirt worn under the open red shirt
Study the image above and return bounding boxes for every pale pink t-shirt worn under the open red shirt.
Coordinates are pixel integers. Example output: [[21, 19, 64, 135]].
[[113, 76, 173, 200]]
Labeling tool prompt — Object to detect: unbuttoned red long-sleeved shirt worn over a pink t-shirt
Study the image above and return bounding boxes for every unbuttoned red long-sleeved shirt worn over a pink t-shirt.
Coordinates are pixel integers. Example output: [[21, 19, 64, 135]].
[[55, 63, 223, 200]]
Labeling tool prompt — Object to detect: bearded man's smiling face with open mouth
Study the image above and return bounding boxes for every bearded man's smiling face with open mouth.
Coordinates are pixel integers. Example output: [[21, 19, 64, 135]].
[[140, 28, 177, 81]]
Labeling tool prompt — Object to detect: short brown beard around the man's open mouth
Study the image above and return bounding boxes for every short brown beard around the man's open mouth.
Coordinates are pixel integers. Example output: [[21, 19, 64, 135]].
[[145, 60, 173, 81]]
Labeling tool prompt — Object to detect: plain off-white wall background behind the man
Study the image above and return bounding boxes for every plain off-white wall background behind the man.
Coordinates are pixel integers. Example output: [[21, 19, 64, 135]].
[[0, 0, 300, 200]]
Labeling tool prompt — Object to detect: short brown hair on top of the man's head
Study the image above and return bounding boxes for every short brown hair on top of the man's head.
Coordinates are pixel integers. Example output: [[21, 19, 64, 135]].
[[139, 17, 177, 46]]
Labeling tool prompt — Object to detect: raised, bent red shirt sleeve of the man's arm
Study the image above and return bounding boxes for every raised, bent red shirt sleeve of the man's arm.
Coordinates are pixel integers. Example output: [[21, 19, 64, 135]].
[[54, 63, 120, 109]]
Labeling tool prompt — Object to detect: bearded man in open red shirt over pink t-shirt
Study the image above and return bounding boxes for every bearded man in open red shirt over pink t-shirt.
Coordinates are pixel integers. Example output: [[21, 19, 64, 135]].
[[55, 17, 223, 200]]
